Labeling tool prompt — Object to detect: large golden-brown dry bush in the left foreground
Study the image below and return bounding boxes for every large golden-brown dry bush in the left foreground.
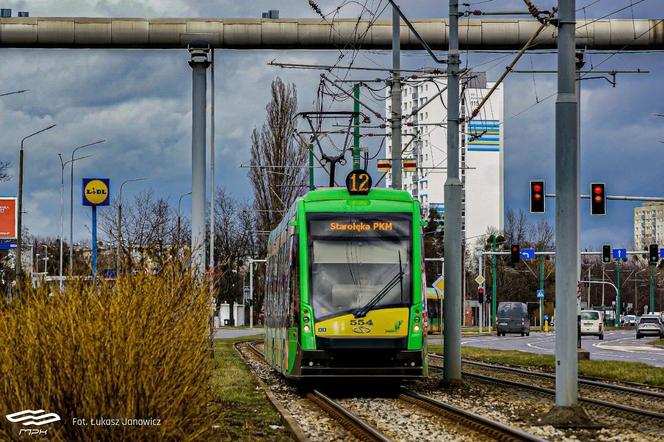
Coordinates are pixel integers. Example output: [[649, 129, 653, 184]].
[[0, 266, 212, 441]]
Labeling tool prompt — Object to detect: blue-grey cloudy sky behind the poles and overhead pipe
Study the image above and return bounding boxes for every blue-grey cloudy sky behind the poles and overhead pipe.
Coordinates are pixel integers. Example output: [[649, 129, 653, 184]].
[[0, 0, 664, 248]]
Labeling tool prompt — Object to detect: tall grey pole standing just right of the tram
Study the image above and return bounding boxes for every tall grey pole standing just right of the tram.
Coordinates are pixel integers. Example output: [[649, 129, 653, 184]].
[[443, 0, 462, 383]]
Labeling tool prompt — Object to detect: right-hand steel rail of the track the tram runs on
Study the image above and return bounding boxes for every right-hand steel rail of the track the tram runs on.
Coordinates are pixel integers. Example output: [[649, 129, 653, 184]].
[[399, 390, 545, 442]]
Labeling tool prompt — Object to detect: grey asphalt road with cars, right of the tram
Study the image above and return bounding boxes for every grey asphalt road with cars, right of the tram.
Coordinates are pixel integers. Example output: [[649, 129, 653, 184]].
[[429, 329, 664, 367]]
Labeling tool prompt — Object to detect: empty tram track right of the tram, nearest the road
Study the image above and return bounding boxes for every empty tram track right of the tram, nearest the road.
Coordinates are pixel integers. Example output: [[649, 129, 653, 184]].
[[429, 355, 664, 427]]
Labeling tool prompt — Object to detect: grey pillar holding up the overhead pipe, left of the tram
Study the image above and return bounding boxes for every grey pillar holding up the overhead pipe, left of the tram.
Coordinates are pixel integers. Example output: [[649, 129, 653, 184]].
[[189, 45, 210, 275]]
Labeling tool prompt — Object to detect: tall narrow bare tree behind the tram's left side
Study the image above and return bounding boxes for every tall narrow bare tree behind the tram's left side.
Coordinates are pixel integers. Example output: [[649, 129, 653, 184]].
[[249, 78, 307, 252]]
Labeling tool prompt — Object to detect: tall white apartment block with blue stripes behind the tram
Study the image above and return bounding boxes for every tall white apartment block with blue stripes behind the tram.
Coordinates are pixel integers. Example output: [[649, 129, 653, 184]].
[[386, 73, 504, 243]]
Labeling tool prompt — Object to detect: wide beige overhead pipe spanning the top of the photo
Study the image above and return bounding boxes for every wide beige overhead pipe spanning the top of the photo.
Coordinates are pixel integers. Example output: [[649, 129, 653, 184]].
[[0, 17, 664, 51]]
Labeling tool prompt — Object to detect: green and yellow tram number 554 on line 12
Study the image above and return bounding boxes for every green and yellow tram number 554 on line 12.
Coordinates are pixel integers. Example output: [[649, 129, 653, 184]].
[[265, 171, 427, 378]]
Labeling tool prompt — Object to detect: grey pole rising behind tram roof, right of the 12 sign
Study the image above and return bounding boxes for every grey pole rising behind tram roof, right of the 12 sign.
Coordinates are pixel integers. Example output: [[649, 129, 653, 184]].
[[386, 3, 401, 190]]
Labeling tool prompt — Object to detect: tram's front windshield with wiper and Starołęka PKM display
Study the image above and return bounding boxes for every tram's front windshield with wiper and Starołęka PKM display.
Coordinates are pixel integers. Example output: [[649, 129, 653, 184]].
[[309, 213, 412, 319]]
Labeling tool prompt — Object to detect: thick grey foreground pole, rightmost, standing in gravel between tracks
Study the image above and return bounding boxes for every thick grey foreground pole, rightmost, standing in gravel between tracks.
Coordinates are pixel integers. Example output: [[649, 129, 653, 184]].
[[555, 0, 580, 408]]
